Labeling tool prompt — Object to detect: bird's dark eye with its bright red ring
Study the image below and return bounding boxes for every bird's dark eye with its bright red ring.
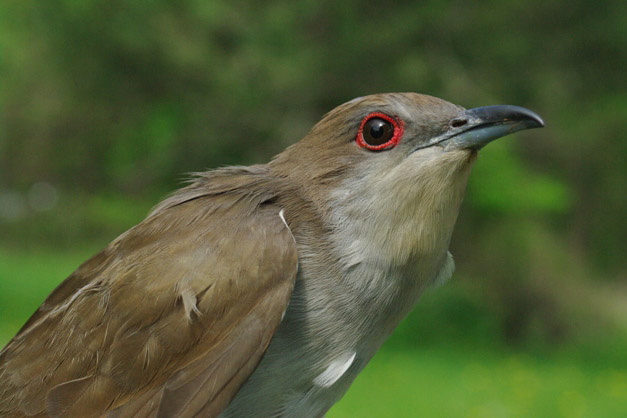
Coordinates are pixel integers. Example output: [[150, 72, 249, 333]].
[[357, 112, 403, 151]]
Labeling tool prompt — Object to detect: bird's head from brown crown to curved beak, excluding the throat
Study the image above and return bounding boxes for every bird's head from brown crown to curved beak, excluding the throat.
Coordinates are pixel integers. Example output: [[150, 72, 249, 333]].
[[272, 93, 544, 207]]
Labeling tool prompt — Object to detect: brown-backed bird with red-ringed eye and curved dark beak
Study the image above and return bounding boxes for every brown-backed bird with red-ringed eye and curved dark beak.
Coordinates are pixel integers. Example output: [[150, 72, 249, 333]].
[[0, 93, 544, 418]]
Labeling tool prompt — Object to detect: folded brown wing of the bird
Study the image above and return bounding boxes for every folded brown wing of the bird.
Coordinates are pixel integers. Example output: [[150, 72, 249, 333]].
[[0, 190, 297, 417]]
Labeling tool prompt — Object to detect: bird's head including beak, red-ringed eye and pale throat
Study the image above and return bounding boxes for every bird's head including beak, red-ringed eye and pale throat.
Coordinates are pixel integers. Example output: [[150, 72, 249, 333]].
[[271, 93, 543, 262]]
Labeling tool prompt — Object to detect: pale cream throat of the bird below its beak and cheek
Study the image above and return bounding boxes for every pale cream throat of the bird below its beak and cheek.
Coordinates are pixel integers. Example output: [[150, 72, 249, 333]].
[[331, 151, 474, 268]]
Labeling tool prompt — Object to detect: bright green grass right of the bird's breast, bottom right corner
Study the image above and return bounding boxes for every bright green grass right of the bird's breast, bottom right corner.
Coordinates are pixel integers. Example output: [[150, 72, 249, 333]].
[[327, 347, 627, 418]]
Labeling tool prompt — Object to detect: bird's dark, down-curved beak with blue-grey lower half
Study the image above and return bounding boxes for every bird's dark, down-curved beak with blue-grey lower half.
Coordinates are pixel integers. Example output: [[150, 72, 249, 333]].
[[413, 105, 544, 151]]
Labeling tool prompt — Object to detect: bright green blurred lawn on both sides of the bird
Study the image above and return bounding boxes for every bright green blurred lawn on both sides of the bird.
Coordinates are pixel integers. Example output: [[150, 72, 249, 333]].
[[0, 247, 627, 418]]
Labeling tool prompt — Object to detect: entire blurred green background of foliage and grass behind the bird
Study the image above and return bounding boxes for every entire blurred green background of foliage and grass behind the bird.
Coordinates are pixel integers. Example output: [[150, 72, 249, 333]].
[[0, 0, 627, 416]]
